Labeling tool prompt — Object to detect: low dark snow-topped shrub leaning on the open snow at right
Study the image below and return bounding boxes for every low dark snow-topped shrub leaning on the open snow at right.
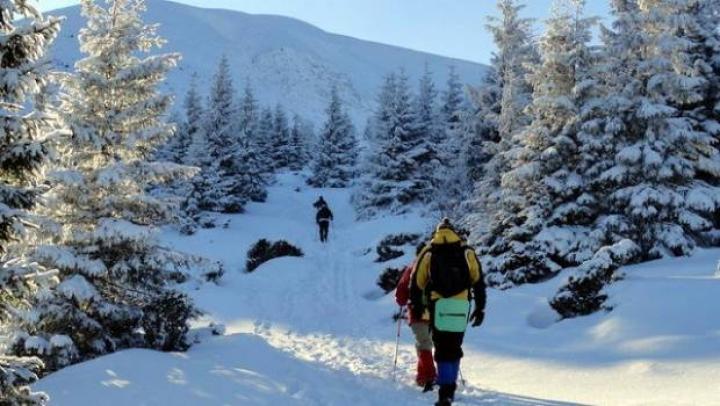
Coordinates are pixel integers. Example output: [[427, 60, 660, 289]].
[[550, 240, 640, 318]]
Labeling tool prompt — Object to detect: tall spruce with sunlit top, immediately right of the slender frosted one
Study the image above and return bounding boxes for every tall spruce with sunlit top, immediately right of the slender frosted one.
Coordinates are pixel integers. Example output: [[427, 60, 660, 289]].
[[485, 0, 600, 284]]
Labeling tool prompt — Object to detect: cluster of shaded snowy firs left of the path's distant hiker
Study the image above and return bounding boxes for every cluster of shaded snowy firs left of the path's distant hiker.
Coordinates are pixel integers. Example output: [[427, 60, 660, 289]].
[[156, 57, 315, 234]]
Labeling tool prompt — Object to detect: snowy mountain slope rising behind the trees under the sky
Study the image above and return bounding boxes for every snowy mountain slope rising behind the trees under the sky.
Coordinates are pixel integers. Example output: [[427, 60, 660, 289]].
[[43, 0, 485, 126]]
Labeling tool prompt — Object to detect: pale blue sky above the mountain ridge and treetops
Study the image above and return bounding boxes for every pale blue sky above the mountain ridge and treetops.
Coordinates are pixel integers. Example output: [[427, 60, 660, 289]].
[[39, 0, 608, 63]]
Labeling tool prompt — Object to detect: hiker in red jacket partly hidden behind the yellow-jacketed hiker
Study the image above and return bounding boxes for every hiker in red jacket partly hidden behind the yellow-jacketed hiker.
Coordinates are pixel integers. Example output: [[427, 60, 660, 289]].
[[395, 244, 437, 392]]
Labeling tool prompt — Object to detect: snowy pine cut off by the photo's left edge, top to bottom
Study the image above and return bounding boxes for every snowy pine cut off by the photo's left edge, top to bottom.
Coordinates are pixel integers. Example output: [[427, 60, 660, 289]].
[[0, 0, 60, 406]]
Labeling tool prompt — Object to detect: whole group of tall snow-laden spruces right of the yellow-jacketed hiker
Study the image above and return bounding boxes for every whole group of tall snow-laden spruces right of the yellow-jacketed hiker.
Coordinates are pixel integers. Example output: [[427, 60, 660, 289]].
[[460, 0, 720, 317]]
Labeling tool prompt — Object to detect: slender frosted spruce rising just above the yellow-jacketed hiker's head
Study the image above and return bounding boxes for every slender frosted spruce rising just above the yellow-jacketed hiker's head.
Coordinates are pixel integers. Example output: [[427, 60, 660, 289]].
[[464, 0, 537, 241]]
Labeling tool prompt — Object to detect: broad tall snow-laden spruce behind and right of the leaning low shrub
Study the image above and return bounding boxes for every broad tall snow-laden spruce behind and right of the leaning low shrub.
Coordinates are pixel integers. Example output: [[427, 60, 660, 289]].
[[600, 0, 718, 259]]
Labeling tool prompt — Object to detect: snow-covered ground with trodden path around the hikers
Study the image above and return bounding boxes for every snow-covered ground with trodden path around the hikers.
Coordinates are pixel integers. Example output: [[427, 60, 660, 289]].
[[36, 175, 720, 406]]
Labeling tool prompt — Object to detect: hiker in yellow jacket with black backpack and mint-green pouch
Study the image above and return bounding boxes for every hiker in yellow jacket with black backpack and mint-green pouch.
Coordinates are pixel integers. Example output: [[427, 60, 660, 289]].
[[410, 219, 486, 406]]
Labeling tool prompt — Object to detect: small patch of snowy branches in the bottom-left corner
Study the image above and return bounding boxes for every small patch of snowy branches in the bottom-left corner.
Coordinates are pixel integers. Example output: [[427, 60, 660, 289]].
[[0, 356, 49, 406]]
